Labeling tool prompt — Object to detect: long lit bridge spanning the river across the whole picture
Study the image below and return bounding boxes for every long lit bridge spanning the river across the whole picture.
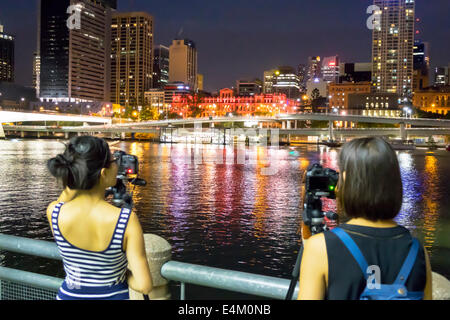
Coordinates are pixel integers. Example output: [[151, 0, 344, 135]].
[[0, 112, 450, 141]]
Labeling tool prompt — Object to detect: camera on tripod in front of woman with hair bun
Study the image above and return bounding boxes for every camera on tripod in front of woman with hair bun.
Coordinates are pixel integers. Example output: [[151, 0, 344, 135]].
[[105, 151, 147, 209]]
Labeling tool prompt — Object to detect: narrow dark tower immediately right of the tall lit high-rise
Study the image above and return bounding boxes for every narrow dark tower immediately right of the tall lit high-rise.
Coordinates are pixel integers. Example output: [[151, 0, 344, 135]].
[[413, 40, 430, 92]]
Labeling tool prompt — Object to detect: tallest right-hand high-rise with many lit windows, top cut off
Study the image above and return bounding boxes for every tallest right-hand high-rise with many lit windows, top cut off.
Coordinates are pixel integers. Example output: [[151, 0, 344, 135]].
[[372, 0, 415, 96]]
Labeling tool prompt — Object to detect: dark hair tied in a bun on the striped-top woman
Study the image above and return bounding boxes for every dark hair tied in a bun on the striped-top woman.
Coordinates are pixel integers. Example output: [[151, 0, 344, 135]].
[[47, 136, 111, 190]]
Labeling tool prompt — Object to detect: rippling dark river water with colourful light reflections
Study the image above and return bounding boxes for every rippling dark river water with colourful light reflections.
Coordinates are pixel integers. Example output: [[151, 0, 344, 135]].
[[0, 140, 450, 298]]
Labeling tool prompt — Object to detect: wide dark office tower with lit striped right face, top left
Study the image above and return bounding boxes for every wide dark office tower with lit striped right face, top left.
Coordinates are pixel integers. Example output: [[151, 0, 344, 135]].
[[37, 0, 116, 102]]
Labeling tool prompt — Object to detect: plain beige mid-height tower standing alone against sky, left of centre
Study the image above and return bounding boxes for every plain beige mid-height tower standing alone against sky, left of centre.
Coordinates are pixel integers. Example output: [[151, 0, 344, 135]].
[[169, 39, 197, 91]]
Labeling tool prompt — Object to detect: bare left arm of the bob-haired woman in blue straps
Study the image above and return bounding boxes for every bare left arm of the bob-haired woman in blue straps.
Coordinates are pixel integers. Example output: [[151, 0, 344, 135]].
[[298, 233, 328, 300]]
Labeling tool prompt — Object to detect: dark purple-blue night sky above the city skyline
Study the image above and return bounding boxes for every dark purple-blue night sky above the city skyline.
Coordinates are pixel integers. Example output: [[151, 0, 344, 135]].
[[0, 0, 450, 91]]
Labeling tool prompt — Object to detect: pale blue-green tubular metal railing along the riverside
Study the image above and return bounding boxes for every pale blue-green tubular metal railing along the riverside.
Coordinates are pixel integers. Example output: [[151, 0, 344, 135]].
[[0, 234, 298, 300]]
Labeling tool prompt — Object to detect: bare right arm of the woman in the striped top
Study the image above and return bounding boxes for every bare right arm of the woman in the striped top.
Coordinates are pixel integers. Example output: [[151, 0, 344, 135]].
[[125, 212, 153, 294]]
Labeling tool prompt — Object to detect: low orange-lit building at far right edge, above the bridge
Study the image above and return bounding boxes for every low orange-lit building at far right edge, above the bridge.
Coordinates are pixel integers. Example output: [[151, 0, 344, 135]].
[[413, 86, 450, 115]]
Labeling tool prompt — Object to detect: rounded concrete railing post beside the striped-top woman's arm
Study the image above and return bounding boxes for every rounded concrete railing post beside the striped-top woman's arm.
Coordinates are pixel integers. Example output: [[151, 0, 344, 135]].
[[129, 234, 172, 300]]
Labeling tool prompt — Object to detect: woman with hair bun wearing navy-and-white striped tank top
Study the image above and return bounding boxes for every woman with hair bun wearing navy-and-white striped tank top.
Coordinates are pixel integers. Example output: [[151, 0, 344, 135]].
[[47, 136, 152, 300]]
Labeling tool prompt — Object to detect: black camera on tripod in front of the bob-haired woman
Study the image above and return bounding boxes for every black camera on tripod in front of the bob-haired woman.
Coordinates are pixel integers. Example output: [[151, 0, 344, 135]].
[[303, 164, 339, 235]]
